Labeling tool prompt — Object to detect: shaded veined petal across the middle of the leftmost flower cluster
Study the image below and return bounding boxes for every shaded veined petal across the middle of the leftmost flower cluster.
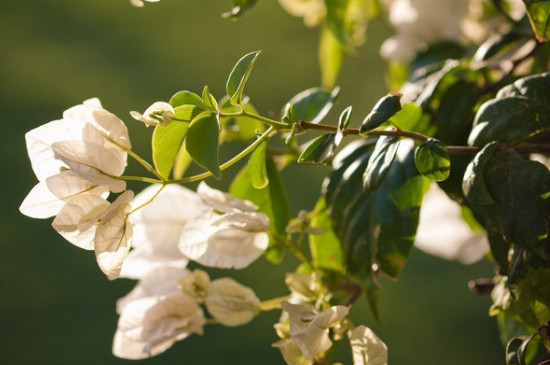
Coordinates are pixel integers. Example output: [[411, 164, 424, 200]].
[[52, 141, 126, 193]]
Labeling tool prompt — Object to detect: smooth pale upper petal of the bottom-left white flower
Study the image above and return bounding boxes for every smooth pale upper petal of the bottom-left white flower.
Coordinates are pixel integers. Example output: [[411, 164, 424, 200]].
[[117, 263, 189, 314]]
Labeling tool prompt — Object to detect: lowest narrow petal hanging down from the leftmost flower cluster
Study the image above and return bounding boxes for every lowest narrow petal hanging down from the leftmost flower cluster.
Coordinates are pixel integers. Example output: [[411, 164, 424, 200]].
[[94, 190, 134, 279]]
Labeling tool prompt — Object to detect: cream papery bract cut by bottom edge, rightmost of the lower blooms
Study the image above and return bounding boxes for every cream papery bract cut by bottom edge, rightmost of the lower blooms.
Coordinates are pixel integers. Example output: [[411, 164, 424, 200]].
[[349, 325, 388, 365]]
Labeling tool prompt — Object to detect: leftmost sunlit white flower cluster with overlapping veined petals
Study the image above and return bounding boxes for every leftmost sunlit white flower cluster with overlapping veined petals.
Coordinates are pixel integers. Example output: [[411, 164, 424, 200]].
[[20, 99, 133, 279]]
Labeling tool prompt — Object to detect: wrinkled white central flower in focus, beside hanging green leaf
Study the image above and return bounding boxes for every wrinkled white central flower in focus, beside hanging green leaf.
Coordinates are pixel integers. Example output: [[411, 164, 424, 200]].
[[178, 183, 269, 269]]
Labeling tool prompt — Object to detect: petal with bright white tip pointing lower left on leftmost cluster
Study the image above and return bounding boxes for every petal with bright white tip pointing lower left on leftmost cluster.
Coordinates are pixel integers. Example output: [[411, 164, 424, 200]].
[[19, 171, 109, 218]]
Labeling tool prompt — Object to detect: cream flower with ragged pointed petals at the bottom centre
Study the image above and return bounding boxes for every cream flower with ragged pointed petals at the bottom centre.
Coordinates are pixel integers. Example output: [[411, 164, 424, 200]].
[[282, 302, 349, 359]]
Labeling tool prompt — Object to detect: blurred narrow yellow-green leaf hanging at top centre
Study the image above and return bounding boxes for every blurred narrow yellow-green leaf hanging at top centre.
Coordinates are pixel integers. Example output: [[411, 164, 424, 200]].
[[319, 27, 344, 89]]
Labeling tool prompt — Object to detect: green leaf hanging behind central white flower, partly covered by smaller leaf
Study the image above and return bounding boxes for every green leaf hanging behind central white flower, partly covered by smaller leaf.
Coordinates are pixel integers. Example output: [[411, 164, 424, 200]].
[[229, 159, 290, 263]]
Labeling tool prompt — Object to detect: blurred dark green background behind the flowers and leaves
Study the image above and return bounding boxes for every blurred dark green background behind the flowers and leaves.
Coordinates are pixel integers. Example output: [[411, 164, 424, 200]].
[[0, 0, 503, 364]]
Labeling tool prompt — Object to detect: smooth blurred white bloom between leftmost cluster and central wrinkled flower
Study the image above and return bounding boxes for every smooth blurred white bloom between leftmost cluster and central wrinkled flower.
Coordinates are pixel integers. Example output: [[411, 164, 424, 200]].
[[120, 184, 211, 279]]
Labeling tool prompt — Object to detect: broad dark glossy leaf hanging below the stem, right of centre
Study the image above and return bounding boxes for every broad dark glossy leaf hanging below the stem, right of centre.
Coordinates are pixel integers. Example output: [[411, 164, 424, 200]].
[[324, 140, 428, 278]]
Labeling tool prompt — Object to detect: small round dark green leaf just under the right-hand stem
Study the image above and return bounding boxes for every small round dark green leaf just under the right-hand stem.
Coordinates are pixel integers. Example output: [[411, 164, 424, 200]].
[[414, 138, 451, 181]]
